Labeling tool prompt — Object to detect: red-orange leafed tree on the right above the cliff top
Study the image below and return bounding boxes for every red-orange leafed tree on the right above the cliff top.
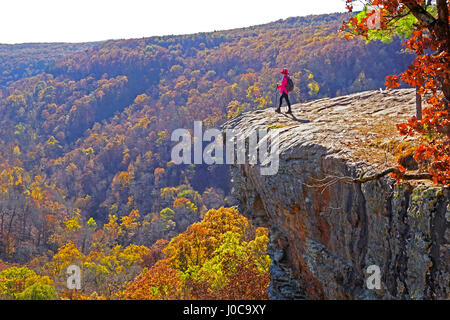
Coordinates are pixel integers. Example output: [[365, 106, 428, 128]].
[[341, 0, 450, 185]]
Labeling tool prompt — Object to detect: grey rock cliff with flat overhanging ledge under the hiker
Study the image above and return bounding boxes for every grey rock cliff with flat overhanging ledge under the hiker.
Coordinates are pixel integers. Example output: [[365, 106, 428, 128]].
[[224, 90, 450, 299]]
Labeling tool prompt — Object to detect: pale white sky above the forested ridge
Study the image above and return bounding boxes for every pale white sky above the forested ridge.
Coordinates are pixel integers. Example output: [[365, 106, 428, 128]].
[[0, 0, 358, 43]]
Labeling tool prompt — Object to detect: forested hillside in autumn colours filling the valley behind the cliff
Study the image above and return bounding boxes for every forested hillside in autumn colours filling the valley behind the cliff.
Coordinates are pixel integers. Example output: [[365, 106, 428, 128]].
[[0, 14, 412, 299]]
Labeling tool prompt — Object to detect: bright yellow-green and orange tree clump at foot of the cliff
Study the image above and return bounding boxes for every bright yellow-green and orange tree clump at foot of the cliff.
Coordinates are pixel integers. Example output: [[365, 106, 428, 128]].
[[123, 207, 271, 299]]
